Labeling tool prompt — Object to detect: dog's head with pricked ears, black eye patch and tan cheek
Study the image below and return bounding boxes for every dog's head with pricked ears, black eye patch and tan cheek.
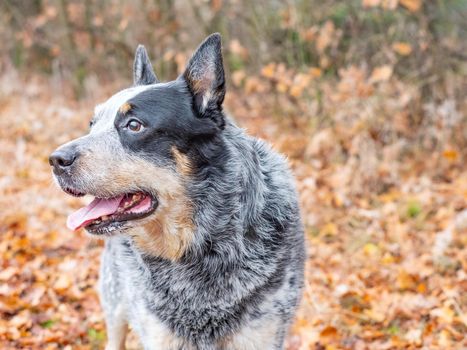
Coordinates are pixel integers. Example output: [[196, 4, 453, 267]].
[[49, 34, 225, 259]]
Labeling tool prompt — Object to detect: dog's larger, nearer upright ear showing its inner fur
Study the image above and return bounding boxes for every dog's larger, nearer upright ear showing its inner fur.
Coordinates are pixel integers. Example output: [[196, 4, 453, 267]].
[[181, 33, 225, 129]]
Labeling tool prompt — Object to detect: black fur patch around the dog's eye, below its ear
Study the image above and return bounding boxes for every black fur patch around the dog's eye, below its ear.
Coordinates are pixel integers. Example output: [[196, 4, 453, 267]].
[[114, 81, 220, 170]]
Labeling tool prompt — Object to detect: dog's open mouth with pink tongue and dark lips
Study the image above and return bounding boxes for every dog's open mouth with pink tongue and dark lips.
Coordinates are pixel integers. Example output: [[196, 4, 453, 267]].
[[67, 192, 158, 233]]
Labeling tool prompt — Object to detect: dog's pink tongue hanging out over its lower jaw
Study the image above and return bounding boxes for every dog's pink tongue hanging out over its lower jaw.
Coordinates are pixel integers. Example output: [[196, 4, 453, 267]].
[[66, 195, 123, 230]]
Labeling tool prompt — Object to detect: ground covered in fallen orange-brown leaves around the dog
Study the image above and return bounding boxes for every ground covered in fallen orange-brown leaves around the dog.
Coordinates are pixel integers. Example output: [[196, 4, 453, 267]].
[[0, 72, 467, 350]]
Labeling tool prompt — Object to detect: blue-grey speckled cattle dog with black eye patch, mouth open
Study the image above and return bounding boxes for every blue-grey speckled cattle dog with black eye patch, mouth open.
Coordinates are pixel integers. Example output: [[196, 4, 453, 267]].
[[49, 33, 305, 350]]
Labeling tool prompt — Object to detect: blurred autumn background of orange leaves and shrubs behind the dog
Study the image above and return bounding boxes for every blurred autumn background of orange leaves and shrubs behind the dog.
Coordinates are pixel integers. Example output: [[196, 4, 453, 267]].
[[0, 0, 467, 350]]
